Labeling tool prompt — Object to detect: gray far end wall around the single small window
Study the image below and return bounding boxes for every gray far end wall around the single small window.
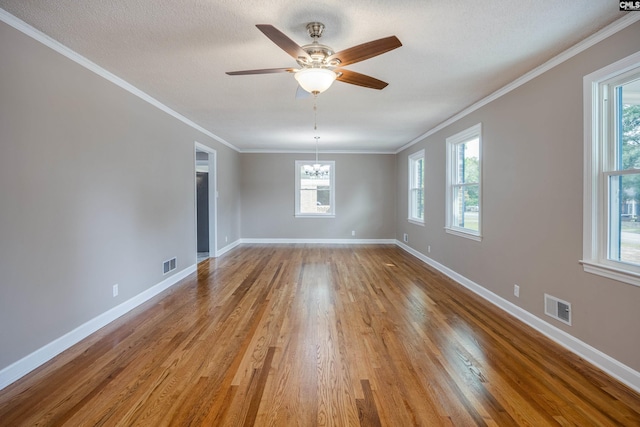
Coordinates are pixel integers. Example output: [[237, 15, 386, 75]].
[[240, 153, 396, 239]]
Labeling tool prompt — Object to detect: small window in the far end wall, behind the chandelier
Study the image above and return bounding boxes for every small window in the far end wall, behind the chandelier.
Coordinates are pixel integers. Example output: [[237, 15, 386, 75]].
[[295, 160, 335, 217]]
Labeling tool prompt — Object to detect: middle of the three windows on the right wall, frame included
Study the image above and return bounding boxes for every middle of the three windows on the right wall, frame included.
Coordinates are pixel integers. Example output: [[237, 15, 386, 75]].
[[445, 123, 482, 241]]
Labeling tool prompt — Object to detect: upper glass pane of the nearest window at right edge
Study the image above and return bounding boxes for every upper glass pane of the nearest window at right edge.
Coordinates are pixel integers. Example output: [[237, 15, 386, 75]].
[[616, 79, 640, 170]]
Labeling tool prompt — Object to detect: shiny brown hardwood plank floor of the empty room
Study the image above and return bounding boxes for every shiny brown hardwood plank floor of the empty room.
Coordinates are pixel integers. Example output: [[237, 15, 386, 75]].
[[0, 245, 640, 426]]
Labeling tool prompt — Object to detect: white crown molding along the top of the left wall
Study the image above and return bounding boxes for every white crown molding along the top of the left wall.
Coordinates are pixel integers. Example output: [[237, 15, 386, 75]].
[[0, 8, 240, 152]]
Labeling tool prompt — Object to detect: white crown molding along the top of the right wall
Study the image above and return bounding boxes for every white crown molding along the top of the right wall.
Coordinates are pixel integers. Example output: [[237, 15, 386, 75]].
[[395, 13, 640, 154]]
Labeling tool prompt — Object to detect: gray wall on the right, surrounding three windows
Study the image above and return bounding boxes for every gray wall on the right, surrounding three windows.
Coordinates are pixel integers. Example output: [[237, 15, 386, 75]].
[[396, 23, 640, 370]]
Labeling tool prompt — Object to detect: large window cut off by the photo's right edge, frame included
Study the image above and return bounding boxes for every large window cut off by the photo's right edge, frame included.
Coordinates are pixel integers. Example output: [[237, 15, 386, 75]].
[[581, 53, 640, 286]]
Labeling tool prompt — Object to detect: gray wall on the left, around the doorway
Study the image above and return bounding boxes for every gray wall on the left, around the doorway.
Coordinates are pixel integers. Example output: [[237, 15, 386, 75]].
[[0, 19, 240, 369]]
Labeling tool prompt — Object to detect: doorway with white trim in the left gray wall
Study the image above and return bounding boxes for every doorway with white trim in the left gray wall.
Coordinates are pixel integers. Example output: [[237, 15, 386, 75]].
[[195, 143, 217, 263]]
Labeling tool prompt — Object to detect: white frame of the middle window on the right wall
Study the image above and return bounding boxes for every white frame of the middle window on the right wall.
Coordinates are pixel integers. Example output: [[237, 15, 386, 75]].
[[445, 123, 482, 241]]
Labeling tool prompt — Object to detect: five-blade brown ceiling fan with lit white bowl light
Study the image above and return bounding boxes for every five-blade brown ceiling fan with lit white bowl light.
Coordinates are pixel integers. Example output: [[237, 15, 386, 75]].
[[227, 22, 402, 95]]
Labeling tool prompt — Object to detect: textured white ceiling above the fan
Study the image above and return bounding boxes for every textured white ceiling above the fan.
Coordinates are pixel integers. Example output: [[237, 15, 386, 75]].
[[0, 0, 624, 152]]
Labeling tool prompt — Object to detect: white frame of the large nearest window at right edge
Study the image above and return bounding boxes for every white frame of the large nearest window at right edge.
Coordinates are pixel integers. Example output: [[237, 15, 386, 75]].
[[580, 52, 640, 286]]
